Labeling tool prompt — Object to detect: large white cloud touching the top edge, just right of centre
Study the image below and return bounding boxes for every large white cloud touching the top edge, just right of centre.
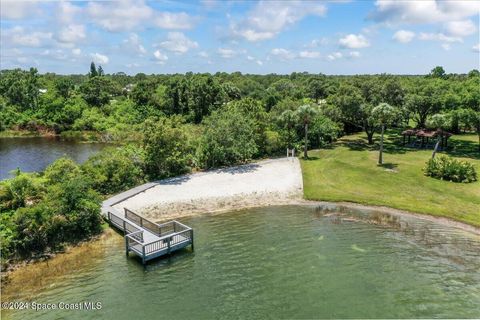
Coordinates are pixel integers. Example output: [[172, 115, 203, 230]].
[[230, 1, 327, 42]]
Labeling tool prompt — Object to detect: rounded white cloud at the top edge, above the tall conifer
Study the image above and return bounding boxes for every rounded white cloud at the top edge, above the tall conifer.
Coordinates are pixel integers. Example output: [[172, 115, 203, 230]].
[[87, 0, 153, 32]]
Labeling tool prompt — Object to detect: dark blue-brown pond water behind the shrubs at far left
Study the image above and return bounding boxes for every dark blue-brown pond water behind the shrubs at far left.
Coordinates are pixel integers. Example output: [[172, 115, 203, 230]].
[[0, 137, 105, 180]]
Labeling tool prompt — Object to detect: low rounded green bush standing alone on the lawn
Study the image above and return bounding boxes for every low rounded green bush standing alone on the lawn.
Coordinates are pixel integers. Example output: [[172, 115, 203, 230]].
[[423, 156, 477, 183]]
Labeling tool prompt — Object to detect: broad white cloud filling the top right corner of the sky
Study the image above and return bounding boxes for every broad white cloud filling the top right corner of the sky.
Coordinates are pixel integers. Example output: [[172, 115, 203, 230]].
[[370, 0, 480, 24]]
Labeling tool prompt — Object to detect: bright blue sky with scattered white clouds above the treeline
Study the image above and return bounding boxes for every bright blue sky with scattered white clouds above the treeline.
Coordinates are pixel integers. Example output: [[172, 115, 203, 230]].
[[0, 0, 480, 74]]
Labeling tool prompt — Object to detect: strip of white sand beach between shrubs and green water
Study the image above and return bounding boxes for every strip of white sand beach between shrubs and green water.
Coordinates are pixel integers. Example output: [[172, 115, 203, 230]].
[[114, 158, 303, 220]]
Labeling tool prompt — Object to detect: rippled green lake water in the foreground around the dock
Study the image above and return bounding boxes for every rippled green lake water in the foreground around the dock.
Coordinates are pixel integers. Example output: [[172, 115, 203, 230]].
[[5, 206, 480, 320]]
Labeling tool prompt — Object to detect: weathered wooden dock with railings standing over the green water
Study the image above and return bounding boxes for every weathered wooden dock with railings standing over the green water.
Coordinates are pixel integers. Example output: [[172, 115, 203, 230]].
[[105, 207, 193, 264]]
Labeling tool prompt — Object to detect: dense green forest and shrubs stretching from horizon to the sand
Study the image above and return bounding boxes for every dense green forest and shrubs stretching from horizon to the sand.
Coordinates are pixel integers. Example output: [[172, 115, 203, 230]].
[[0, 63, 480, 266]]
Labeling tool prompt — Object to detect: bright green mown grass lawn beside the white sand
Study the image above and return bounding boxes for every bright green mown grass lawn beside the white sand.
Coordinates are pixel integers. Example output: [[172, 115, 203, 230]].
[[301, 132, 480, 227]]
